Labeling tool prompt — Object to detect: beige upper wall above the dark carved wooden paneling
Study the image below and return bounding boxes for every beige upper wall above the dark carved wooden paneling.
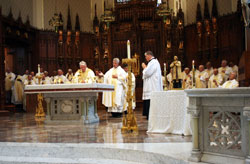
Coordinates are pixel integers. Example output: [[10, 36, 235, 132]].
[[0, 0, 242, 32]]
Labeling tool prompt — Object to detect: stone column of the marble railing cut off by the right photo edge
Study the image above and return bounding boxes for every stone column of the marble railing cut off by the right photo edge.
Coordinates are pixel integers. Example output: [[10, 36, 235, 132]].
[[243, 98, 250, 164]]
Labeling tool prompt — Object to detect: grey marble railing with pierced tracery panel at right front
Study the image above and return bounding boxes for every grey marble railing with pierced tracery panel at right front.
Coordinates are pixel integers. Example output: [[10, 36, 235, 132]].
[[185, 88, 250, 164]]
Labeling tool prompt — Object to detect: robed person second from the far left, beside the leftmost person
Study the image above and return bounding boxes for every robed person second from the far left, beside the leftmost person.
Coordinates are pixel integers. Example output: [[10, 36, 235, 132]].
[[12, 75, 23, 104]]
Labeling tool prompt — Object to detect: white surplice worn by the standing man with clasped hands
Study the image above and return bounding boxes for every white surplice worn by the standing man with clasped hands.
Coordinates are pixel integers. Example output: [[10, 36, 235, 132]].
[[142, 59, 163, 100]]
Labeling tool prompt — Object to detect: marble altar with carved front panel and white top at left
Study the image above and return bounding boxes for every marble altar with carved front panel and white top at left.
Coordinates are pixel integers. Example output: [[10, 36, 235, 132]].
[[24, 83, 114, 124]]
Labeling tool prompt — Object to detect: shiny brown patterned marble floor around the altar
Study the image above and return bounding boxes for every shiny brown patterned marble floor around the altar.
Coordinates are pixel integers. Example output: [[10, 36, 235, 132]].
[[0, 110, 191, 143]]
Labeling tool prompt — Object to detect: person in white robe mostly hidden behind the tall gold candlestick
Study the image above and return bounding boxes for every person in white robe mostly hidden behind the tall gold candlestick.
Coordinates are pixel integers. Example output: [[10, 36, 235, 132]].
[[122, 64, 136, 111]]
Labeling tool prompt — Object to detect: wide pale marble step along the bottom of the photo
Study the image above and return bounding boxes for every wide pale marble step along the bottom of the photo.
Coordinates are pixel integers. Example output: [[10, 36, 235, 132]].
[[0, 142, 189, 164]]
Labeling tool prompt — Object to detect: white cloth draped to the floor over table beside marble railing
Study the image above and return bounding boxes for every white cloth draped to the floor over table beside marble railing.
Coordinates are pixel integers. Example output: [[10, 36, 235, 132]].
[[147, 90, 192, 135]]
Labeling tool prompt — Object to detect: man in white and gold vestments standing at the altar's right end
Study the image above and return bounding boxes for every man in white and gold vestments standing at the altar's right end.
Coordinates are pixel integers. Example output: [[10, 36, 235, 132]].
[[102, 58, 127, 117]]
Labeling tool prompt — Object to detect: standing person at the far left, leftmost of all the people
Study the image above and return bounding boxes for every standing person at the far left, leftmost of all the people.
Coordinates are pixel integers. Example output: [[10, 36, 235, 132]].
[[5, 68, 16, 104]]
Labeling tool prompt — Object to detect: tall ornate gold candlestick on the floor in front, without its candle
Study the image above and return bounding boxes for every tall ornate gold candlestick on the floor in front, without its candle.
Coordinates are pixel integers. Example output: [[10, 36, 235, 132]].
[[122, 59, 138, 134]]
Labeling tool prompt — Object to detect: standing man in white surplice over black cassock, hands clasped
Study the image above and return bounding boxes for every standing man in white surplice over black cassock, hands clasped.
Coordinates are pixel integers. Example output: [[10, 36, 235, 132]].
[[142, 51, 163, 119]]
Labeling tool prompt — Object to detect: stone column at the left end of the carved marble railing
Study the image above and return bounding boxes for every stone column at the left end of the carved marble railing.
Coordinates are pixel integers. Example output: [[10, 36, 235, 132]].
[[187, 97, 201, 162]]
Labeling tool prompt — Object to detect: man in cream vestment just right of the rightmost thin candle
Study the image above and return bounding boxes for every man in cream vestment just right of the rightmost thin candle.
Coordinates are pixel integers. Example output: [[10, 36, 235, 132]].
[[195, 65, 209, 88]]
